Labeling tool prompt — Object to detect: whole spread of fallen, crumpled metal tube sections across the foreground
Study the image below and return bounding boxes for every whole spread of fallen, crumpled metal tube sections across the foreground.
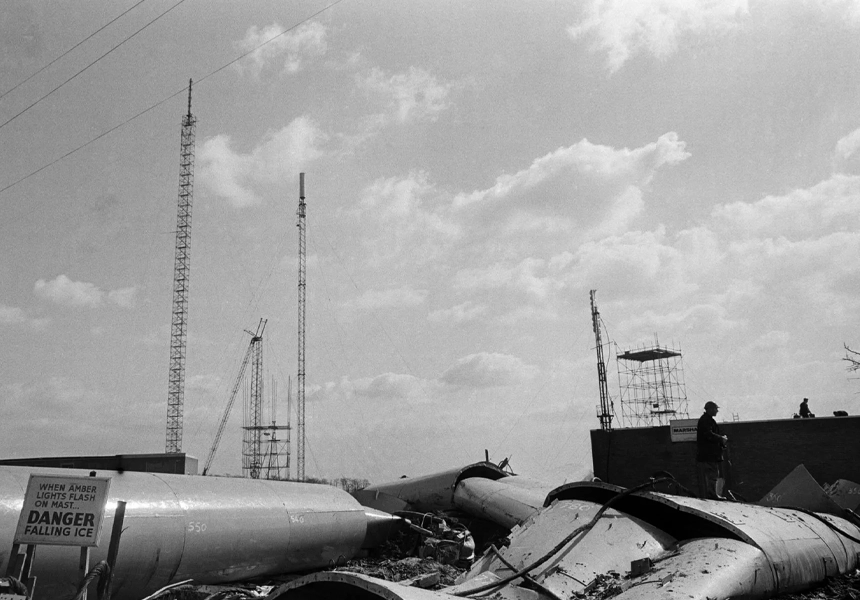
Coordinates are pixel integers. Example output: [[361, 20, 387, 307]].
[[0, 462, 860, 600]]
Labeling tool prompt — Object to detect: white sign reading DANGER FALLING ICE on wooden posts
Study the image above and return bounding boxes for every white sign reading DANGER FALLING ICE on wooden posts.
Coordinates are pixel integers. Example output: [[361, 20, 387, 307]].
[[15, 475, 110, 546]]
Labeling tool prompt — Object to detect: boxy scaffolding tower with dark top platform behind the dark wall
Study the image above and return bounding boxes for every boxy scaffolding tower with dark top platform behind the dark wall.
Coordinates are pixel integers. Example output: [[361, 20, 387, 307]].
[[615, 340, 689, 427]]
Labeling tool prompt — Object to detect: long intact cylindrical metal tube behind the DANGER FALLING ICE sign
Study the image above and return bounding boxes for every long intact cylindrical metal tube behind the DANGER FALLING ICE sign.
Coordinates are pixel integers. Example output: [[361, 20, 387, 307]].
[[0, 467, 367, 600]]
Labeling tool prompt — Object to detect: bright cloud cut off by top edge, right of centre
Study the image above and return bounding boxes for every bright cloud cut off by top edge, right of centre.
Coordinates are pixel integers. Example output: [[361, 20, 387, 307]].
[[567, 0, 749, 73]]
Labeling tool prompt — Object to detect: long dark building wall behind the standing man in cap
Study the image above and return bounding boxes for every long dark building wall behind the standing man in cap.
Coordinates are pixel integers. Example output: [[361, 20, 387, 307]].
[[591, 416, 860, 502]]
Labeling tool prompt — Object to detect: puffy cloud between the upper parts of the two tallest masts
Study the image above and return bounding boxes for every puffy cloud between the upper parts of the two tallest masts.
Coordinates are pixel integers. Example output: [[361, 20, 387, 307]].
[[198, 117, 327, 208]]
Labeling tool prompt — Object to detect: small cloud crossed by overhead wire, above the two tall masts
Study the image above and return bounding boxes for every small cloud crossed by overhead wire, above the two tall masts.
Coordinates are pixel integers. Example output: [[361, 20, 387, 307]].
[[236, 21, 328, 77]]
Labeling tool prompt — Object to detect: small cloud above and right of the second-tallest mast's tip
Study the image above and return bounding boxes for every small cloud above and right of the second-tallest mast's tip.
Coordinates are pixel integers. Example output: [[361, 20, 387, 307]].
[[358, 67, 452, 124]]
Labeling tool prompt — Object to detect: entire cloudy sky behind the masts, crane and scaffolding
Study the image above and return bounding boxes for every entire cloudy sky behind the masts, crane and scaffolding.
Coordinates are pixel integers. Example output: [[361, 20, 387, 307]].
[[0, 0, 860, 483]]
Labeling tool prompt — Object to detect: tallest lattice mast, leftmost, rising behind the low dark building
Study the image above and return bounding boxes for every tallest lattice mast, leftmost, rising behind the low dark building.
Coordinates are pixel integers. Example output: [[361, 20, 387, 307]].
[[165, 79, 197, 453]]
